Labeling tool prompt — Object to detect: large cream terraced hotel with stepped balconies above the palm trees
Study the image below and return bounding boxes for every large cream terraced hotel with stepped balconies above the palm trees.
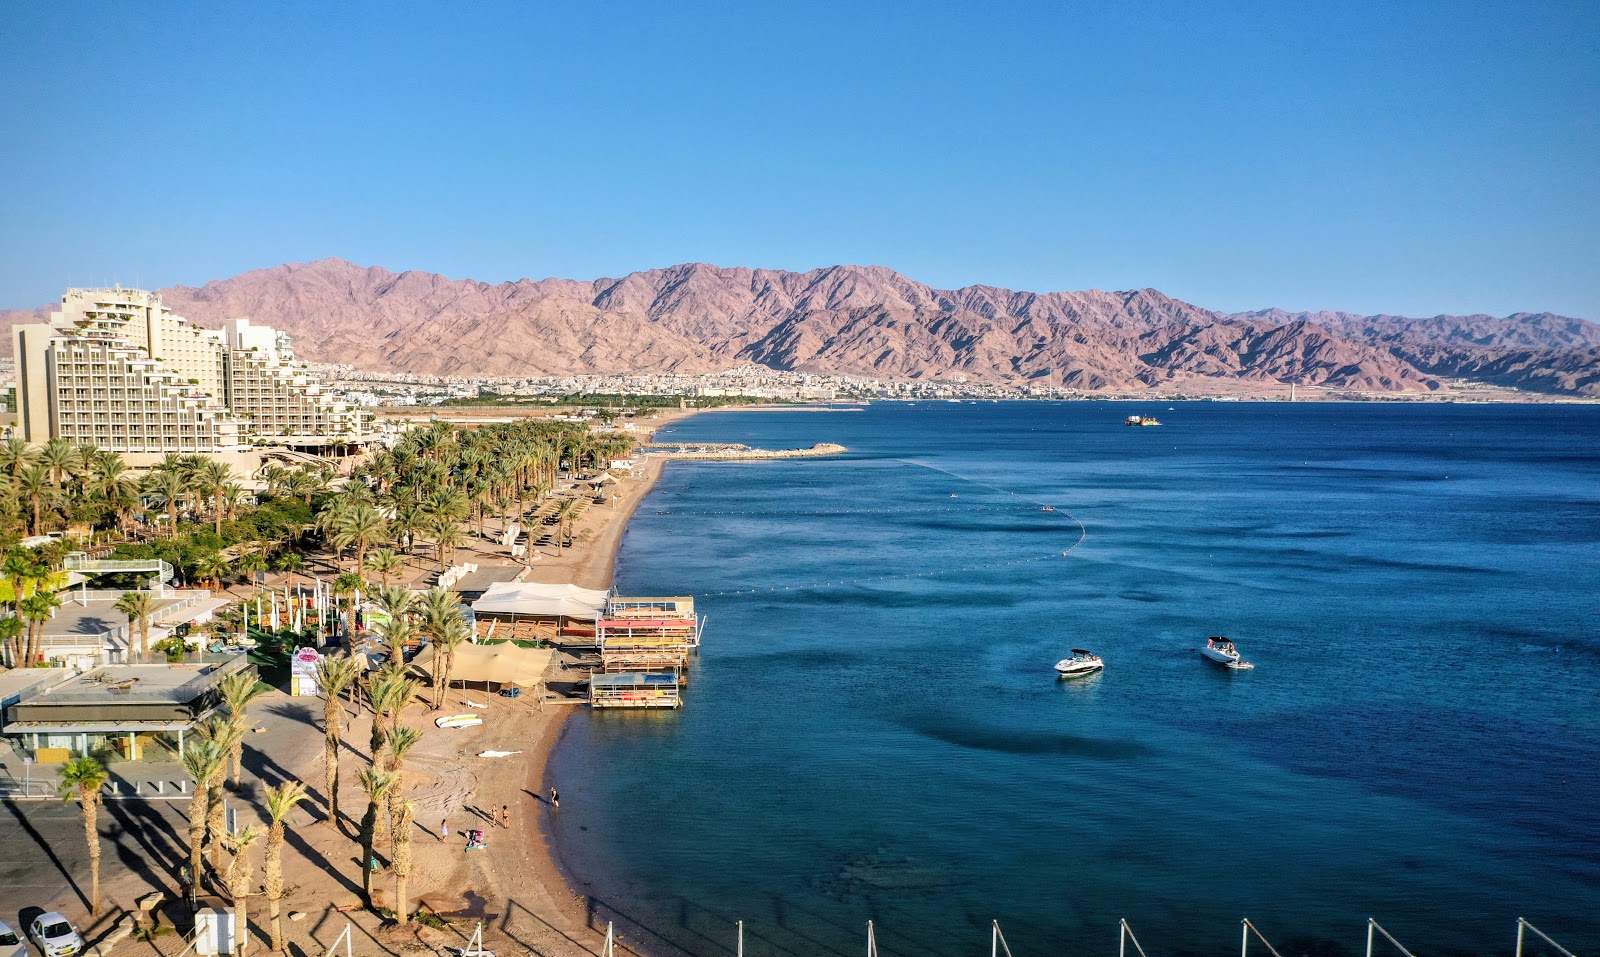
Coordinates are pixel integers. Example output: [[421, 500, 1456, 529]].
[[13, 288, 373, 470]]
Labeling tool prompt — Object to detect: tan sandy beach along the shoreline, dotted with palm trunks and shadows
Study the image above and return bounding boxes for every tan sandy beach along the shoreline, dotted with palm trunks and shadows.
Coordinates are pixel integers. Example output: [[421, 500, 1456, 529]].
[[67, 410, 707, 957]]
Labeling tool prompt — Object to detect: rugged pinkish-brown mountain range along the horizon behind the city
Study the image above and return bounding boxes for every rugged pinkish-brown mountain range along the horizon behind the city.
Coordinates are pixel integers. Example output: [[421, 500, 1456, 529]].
[[0, 259, 1600, 395]]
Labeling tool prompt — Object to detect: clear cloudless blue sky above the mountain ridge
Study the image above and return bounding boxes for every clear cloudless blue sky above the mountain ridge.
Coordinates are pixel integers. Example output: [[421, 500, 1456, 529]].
[[0, 0, 1600, 320]]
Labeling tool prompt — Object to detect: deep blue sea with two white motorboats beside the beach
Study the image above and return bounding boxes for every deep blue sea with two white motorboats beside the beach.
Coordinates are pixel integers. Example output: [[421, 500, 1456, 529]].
[[549, 402, 1600, 957]]
